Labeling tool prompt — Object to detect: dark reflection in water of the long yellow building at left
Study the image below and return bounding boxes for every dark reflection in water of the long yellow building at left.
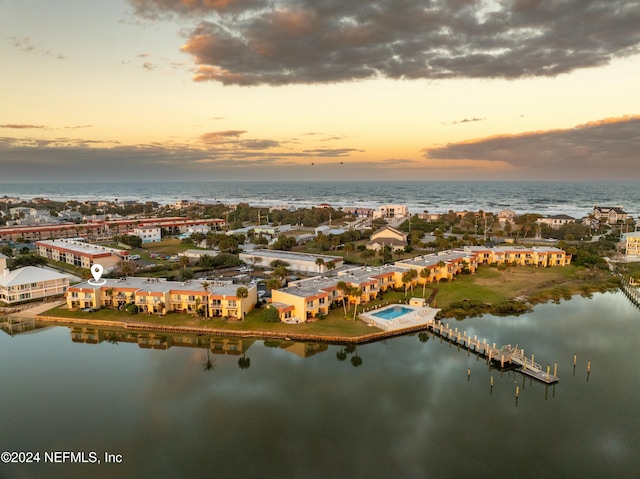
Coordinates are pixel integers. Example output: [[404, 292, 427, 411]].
[[65, 326, 255, 356]]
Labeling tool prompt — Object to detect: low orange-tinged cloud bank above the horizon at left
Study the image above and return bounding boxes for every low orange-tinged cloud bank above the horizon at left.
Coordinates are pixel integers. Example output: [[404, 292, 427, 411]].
[[0, 130, 362, 181]]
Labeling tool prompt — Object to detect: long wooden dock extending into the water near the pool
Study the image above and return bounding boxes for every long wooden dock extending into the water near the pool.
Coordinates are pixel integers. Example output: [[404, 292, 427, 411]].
[[426, 320, 559, 384]]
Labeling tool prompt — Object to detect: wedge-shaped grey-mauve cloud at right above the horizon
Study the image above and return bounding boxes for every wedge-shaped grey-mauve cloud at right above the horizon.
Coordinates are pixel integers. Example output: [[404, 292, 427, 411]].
[[423, 115, 640, 178]]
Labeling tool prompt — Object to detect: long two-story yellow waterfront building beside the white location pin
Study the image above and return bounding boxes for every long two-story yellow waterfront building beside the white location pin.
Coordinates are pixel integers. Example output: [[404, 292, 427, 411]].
[[67, 277, 258, 319]]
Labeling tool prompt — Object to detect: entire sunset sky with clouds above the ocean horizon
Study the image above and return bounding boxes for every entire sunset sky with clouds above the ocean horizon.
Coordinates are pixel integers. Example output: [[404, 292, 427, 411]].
[[0, 0, 640, 183]]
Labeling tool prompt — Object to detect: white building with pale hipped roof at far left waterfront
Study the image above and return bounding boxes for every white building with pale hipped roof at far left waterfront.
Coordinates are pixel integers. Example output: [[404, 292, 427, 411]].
[[0, 254, 69, 304]]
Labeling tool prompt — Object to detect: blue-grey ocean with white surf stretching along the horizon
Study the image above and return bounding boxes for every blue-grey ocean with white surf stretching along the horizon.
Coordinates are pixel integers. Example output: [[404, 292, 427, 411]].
[[0, 181, 640, 218]]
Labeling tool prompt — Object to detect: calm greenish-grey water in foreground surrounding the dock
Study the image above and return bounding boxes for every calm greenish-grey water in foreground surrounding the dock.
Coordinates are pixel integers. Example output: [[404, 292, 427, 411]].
[[0, 293, 640, 479]]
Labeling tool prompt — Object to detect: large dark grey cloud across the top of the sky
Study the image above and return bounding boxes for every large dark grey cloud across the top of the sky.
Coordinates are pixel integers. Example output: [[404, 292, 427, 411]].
[[130, 0, 640, 85]]
